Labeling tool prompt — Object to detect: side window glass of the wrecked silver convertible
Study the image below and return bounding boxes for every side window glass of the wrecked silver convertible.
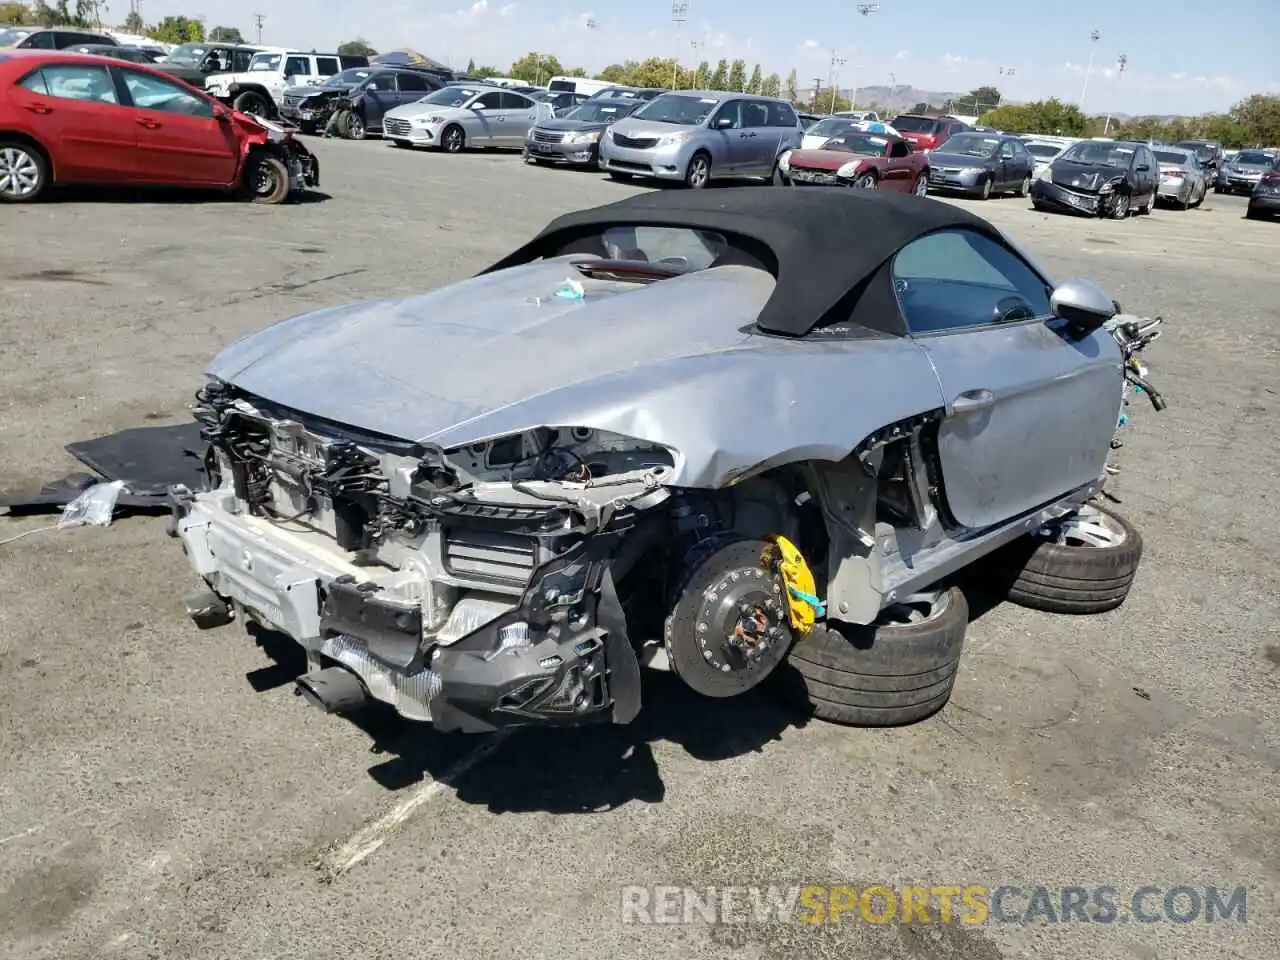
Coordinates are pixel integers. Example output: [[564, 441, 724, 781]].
[[892, 229, 1050, 334]]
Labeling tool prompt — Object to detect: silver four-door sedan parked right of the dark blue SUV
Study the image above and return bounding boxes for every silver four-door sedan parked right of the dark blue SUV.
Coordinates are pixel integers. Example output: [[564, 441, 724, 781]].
[[373, 86, 552, 154]]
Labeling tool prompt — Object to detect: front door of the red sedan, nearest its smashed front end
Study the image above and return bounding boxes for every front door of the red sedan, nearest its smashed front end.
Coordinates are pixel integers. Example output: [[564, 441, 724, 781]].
[[114, 67, 241, 187]]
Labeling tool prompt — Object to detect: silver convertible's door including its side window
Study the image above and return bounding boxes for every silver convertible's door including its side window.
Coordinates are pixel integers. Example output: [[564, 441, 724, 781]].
[[891, 228, 1123, 529]]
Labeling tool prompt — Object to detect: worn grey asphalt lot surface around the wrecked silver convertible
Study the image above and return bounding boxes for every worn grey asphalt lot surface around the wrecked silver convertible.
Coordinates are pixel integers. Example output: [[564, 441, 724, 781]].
[[0, 141, 1280, 960]]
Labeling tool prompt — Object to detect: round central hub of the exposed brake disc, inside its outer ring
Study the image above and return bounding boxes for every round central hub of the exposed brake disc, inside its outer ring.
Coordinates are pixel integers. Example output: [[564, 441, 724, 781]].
[[695, 567, 787, 673]]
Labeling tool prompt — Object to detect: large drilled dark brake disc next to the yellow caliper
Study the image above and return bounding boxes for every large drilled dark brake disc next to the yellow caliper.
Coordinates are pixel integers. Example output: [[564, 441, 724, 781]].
[[663, 538, 792, 699]]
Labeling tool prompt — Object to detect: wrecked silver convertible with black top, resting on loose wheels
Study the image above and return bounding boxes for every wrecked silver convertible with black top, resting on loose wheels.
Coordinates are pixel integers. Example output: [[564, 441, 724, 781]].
[[174, 185, 1162, 732]]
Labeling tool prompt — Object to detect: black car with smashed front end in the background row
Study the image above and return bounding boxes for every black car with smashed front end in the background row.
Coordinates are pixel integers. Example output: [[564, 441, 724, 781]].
[[1032, 140, 1160, 220]]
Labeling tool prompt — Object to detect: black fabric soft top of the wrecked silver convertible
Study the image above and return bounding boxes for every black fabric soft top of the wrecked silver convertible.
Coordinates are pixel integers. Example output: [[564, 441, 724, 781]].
[[481, 187, 1005, 337]]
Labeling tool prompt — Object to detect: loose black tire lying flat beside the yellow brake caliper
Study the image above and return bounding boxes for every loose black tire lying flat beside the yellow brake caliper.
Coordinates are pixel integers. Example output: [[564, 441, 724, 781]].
[[771, 588, 969, 727]]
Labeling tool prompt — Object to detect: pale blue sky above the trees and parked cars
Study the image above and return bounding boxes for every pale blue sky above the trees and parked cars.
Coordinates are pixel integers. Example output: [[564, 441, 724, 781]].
[[145, 0, 1280, 114]]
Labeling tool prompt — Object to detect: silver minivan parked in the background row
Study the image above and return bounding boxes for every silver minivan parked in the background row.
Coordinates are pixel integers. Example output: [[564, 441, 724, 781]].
[[600, 92, 801, 189]]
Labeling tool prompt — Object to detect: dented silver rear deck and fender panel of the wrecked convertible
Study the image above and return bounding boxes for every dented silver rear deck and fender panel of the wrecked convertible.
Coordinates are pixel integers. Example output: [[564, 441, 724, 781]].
[[207, 256, 941, 488]]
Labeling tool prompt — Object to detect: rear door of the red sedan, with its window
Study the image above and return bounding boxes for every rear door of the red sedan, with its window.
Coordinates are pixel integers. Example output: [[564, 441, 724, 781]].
[[9, 63, 137, 183]]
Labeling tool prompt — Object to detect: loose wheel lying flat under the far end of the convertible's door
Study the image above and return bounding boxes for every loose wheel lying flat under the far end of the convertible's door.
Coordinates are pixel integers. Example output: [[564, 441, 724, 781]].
[[982, 504, 1142, 614]]
